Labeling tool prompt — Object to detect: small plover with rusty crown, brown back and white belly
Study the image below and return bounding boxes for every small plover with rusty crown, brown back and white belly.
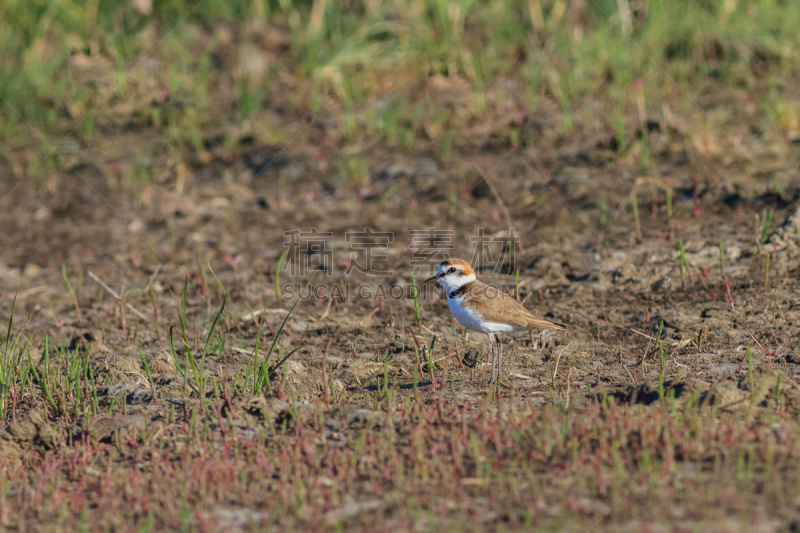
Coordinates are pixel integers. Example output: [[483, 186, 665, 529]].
[[425, 259, 567, 383]]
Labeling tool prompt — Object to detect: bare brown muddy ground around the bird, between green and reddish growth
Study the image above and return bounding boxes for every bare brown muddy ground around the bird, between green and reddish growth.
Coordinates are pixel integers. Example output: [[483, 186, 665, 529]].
[[0, 80, 800, 529]]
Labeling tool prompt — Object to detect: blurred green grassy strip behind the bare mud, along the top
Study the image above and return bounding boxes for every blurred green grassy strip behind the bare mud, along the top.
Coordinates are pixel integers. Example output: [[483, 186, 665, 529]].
[[0, 0, 800, 191]]
